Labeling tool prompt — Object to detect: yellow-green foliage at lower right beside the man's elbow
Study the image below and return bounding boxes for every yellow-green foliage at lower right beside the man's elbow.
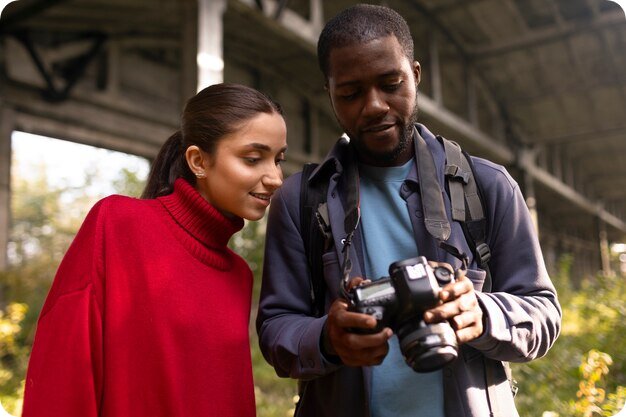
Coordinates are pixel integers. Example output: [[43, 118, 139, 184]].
[[513, 259, 626, 417]]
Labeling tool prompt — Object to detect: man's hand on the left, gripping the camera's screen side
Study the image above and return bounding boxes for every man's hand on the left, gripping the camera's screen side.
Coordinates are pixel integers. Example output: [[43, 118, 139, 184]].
[[323, 299, 393, 366]]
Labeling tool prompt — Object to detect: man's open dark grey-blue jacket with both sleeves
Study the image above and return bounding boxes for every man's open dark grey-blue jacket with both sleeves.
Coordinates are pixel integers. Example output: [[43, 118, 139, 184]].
[[256, 124, 561, 417]]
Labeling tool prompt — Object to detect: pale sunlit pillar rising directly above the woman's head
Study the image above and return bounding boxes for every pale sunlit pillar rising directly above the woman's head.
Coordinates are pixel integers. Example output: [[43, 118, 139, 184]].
[[198, 0, 226, 91]]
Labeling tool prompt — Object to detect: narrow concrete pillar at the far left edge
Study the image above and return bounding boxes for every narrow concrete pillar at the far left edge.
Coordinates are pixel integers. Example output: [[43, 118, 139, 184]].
[[0, 105, 15, 271]]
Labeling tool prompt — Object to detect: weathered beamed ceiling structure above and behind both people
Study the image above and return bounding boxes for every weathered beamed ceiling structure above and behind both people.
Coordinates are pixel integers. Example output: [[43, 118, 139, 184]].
[[0, 0, 626, 250]]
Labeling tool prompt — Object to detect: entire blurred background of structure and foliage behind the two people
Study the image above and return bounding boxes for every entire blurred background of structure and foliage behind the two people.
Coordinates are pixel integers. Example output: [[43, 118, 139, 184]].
[[0, 0, 626, 417]]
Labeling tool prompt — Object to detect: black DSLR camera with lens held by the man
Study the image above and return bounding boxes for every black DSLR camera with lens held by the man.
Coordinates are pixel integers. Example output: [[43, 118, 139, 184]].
[[348, 256, 458, 372]]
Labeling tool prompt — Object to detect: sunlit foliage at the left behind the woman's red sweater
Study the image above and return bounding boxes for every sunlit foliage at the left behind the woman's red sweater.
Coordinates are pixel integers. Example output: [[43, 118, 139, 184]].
[[0, 154, 143, 415]]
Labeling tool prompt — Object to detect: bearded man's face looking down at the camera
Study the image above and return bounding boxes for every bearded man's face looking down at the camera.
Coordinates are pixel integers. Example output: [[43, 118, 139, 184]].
[[327, 35, 420, 166]]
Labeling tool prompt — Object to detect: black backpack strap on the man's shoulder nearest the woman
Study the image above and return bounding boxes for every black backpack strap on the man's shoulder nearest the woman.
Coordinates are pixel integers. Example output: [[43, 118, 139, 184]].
[[300, 163, 332, 317]]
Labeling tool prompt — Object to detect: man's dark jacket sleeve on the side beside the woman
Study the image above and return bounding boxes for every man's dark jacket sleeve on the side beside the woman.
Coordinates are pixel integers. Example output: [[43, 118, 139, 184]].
[[256, 174, 340, 379]]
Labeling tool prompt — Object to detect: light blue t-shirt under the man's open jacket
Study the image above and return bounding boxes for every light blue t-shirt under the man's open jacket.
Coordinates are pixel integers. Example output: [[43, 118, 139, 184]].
[[359, 160, 444, 417]]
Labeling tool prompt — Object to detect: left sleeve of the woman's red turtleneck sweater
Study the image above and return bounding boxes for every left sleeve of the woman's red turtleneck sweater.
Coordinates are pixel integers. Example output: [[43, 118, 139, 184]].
[[23, 200, 103, 417]]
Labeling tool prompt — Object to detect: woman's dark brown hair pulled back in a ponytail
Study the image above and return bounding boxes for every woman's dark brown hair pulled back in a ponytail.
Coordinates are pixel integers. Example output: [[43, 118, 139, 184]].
[[141, 84, 283, 198]]
